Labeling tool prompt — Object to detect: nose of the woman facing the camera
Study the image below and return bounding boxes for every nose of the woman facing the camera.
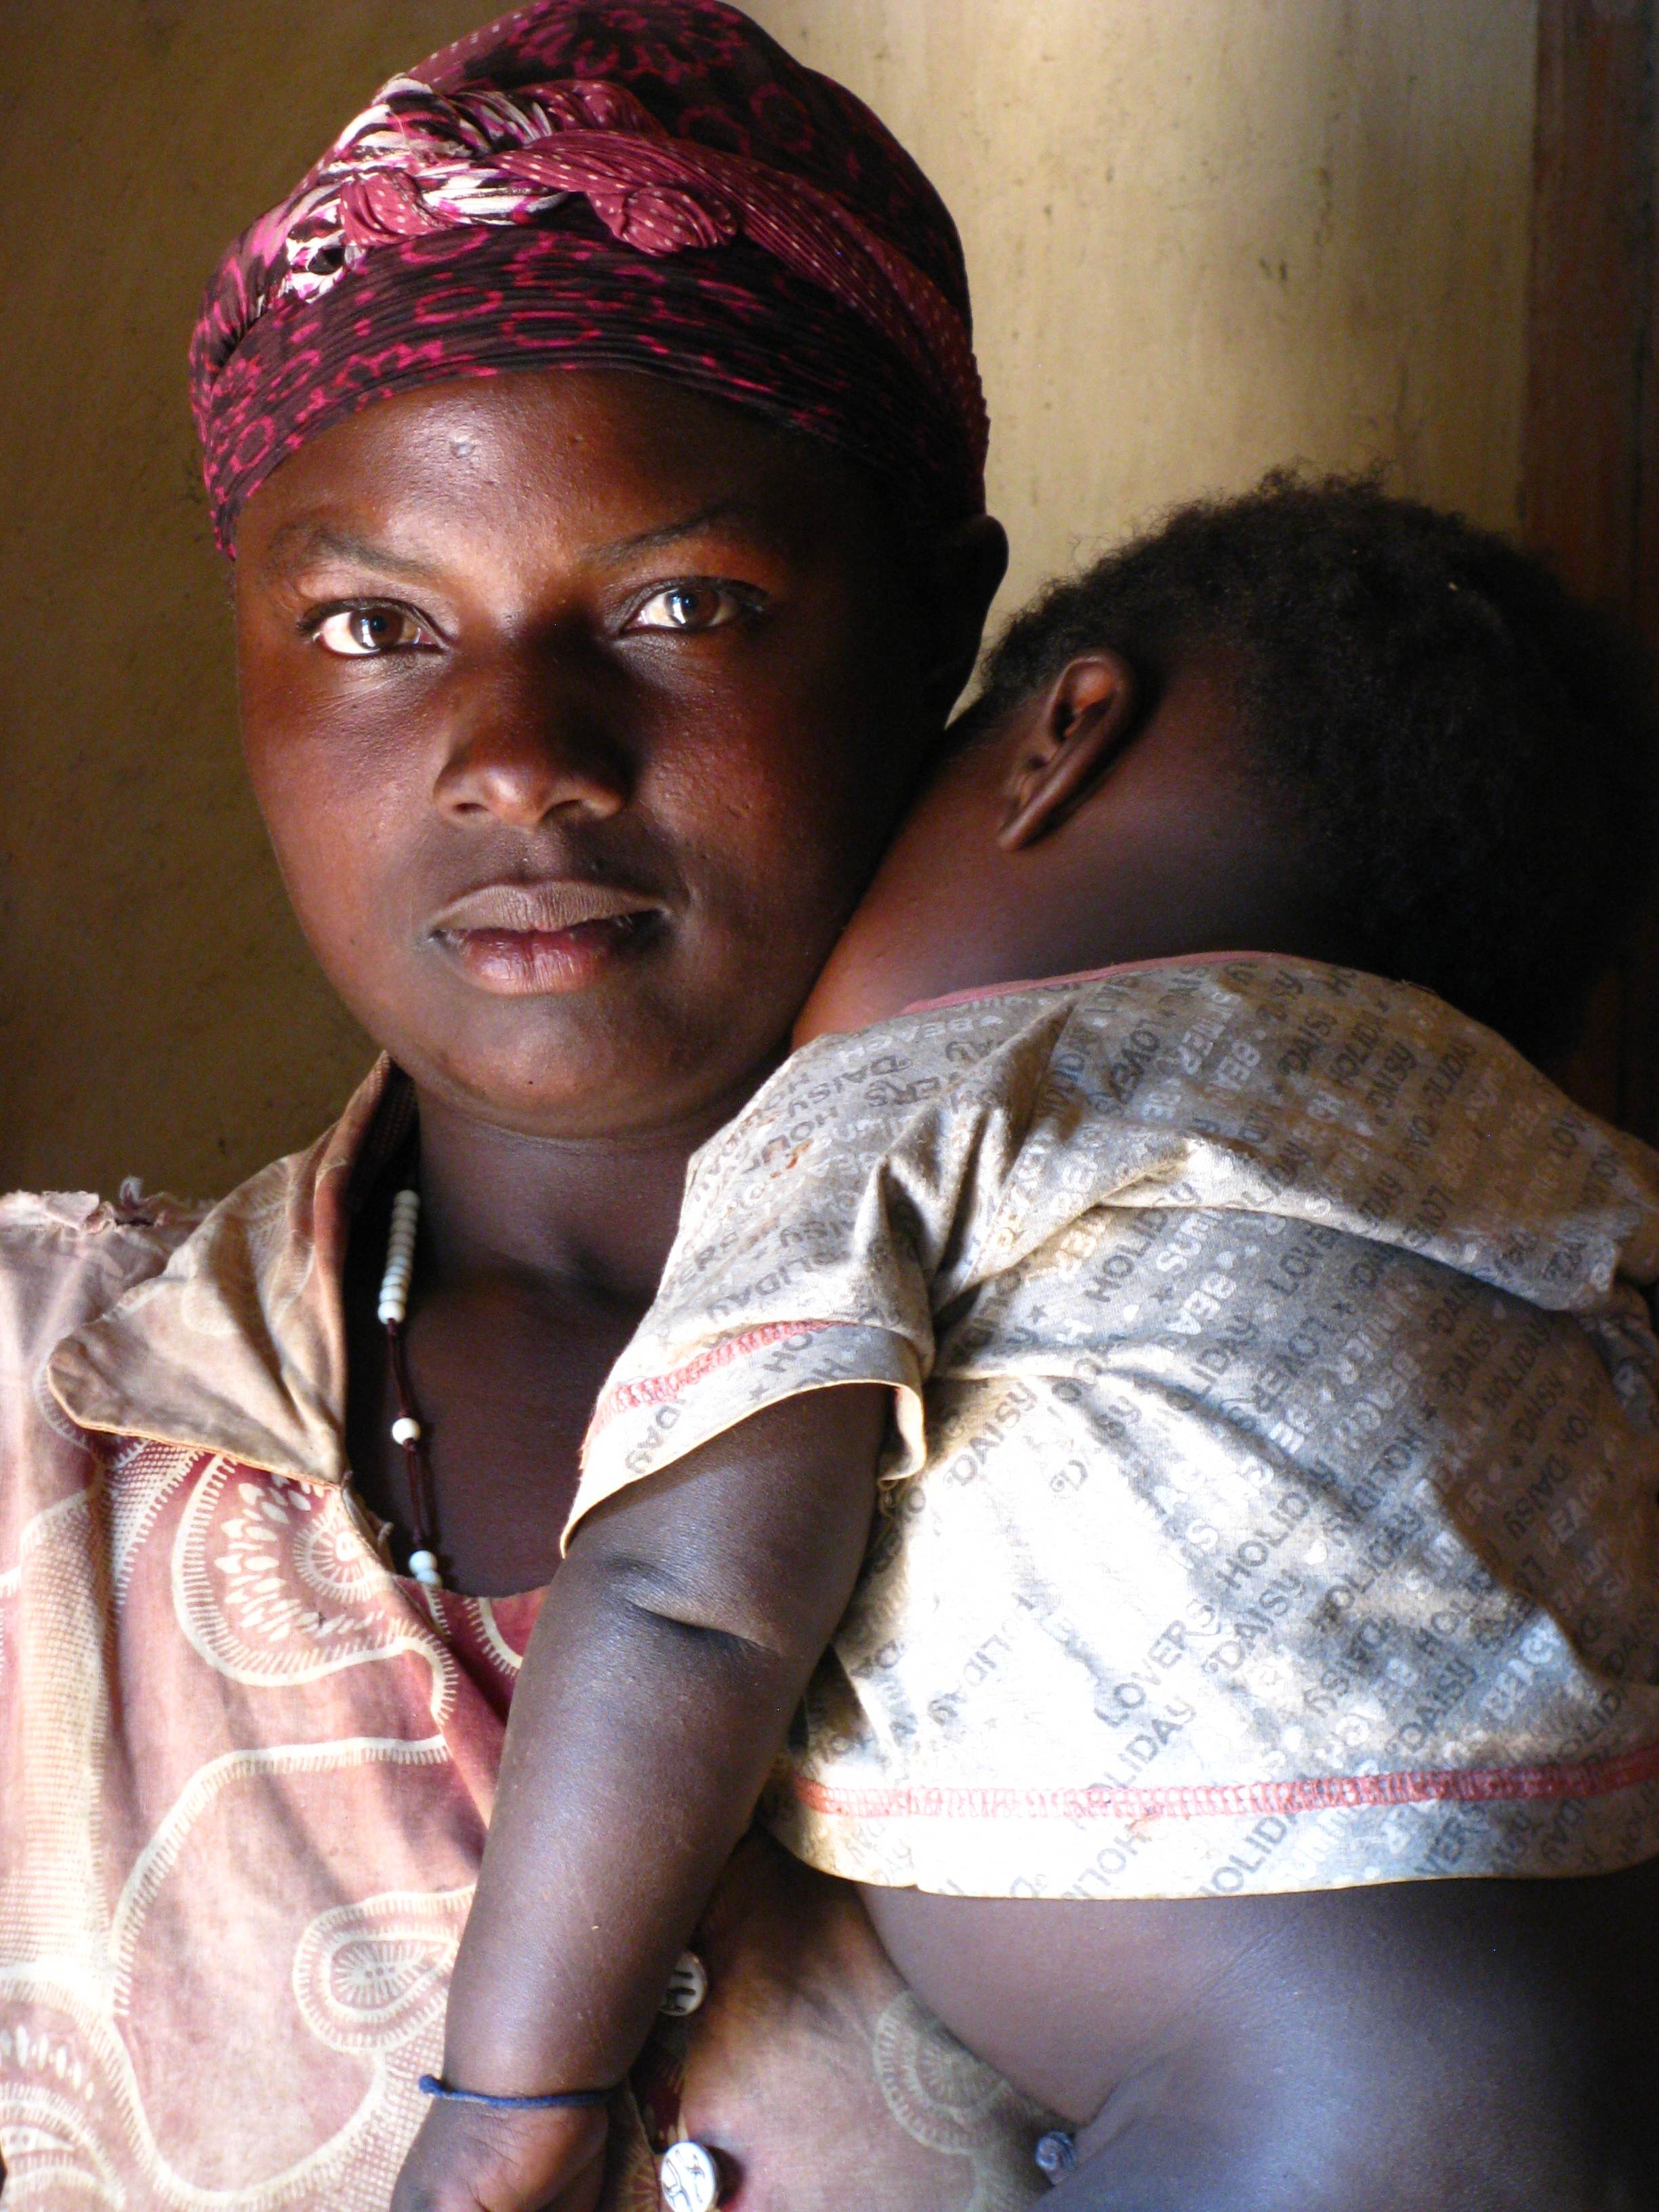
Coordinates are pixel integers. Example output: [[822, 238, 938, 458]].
[[434, 681, 628, 830]]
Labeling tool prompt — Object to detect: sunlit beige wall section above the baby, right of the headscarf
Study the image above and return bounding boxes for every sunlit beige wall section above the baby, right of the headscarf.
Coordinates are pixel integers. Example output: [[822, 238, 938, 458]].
[[750, 0, 1535, 606]]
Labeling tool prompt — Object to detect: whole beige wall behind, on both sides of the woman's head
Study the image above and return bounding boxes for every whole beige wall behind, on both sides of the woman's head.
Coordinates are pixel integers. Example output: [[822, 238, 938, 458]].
[[0, 0, 1535, 1192]]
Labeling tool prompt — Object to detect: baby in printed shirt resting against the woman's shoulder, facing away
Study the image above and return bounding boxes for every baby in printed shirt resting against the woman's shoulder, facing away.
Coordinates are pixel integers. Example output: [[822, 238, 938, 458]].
[[398, 480, 1659, 2212]]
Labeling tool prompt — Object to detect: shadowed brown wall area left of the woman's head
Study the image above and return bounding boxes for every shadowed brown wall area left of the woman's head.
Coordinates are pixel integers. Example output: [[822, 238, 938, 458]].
[[0, 0, 487, 1195]]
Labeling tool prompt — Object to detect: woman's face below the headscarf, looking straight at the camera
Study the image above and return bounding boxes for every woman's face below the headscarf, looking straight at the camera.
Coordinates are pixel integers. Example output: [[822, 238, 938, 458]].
[[237, 369, 989, 1137]]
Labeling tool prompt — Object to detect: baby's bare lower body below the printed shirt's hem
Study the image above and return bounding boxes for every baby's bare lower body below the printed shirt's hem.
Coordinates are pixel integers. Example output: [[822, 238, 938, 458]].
[[861, 1860, 1659, 2212]]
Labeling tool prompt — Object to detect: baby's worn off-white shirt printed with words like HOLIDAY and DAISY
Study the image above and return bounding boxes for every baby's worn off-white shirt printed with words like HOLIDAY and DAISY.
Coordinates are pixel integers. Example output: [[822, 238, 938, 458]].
[[571, 956, 1659, 1898]]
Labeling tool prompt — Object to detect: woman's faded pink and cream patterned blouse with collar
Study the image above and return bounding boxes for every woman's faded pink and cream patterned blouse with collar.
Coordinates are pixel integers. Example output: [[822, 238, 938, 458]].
[[0, 1069, 1044, 2212]]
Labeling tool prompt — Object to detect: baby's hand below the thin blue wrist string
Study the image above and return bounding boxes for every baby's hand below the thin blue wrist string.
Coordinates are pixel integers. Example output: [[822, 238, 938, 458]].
[[392, 2102, 609, 2212]]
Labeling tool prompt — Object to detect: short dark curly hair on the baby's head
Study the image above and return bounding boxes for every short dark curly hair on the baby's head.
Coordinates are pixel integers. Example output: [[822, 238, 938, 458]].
[[971, 471, 1659, 1059]]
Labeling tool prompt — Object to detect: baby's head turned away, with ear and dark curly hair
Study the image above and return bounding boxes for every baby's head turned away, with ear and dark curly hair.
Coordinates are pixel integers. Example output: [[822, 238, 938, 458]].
[[796, 476, 1654, 1059]]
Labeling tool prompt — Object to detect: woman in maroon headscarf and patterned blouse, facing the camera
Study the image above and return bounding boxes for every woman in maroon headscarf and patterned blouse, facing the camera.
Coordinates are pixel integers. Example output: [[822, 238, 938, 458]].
[[0, 0, 1042, 2212]]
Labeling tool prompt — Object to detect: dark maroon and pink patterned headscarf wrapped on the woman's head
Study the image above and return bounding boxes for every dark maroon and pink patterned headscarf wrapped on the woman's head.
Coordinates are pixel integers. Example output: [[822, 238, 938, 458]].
[[190, 0, 987, 551]]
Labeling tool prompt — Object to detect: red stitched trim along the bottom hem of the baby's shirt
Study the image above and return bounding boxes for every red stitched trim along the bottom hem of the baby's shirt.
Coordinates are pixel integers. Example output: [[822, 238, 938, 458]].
[[792, 1743, 1659, 1820]]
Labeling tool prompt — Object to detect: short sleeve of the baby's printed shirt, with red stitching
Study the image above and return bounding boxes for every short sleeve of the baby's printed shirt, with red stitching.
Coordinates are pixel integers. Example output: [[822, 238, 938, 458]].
[[567, 1015, 1070, 1540]]
